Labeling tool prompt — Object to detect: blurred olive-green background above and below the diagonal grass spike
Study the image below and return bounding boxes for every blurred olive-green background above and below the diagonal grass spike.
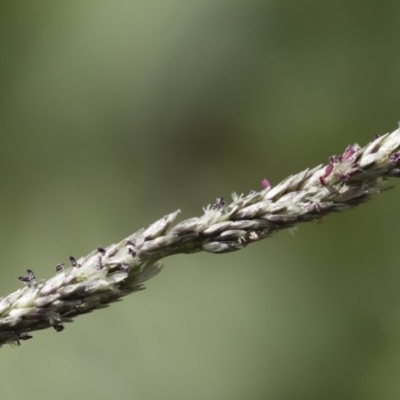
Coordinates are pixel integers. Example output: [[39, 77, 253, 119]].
[[0, 0, 400, 400]]
